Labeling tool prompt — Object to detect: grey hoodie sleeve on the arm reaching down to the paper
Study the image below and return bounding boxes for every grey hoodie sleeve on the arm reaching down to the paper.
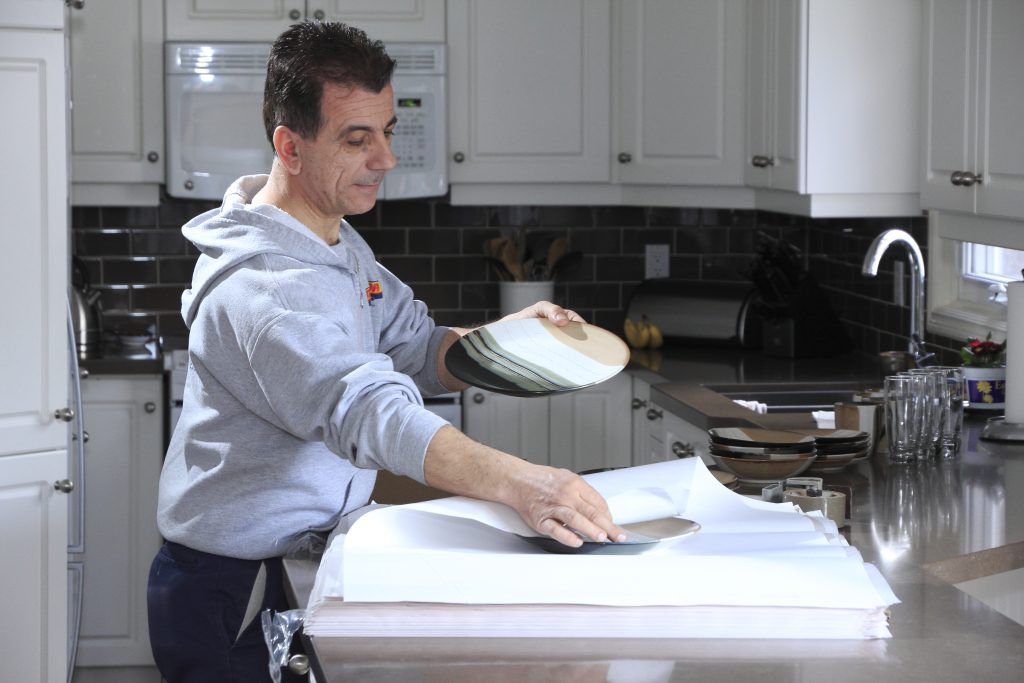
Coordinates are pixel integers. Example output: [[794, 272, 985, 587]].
[[249, 312, 447, 482]]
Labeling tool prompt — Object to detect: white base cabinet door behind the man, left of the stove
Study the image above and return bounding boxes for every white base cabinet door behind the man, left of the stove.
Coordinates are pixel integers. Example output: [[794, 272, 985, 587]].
[[77, 375, 164, 680]]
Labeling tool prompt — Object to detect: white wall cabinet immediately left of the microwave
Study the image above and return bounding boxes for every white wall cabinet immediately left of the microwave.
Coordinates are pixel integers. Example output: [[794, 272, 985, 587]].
[[68, 0, 164, 206]]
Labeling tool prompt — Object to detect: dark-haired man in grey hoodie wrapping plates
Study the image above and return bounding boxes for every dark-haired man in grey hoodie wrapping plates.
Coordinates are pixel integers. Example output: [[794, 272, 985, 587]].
[[148, 23, 623, 683]]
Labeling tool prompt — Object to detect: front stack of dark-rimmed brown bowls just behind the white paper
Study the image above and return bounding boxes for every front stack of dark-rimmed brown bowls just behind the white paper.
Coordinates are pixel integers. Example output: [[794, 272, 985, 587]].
[[708, 427, 816, 483]]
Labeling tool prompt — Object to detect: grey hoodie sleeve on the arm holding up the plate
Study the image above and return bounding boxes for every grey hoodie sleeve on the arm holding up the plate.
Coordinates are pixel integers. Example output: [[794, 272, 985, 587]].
[[377, 263, 450, 396]]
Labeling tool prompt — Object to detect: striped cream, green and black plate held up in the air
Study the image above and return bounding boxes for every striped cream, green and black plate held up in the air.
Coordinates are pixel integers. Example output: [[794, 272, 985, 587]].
[[444, 317, 630, 396]]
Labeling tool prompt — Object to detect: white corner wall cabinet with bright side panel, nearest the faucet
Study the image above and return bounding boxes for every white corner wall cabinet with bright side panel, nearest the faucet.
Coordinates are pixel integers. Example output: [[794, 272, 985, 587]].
[[745, 0, 921, 216]]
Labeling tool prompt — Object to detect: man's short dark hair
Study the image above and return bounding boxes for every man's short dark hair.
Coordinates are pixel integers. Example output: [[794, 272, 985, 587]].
[[263, 22, 394, 146]]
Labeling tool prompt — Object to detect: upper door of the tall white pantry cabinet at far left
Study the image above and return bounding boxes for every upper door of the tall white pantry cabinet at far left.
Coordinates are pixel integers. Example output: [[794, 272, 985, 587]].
[[0, 29, 69, 456]]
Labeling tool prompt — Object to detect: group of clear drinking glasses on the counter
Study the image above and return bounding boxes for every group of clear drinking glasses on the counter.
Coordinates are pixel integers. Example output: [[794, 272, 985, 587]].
[[884, 366, 964, 463]]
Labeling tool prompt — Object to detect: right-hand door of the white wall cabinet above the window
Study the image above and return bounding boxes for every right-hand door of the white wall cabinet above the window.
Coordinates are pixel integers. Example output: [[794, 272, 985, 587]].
[[976, 0, 1024, 218]]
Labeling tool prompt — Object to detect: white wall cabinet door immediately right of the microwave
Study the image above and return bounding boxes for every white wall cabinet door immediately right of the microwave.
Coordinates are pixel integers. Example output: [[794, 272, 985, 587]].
[[447, 0, 611, 182]]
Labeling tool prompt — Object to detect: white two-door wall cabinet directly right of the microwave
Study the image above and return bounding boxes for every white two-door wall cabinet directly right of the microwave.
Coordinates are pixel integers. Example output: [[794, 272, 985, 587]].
[[447, 0, 744, 193]]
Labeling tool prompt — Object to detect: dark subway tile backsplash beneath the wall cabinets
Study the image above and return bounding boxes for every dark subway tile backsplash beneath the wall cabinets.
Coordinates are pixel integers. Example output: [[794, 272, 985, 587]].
[[72, 193, 958, 364]]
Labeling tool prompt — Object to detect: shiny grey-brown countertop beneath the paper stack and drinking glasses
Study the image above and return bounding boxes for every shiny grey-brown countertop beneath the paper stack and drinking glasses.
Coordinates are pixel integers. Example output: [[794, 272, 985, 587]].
[[287, 416, 1024, 683]]
